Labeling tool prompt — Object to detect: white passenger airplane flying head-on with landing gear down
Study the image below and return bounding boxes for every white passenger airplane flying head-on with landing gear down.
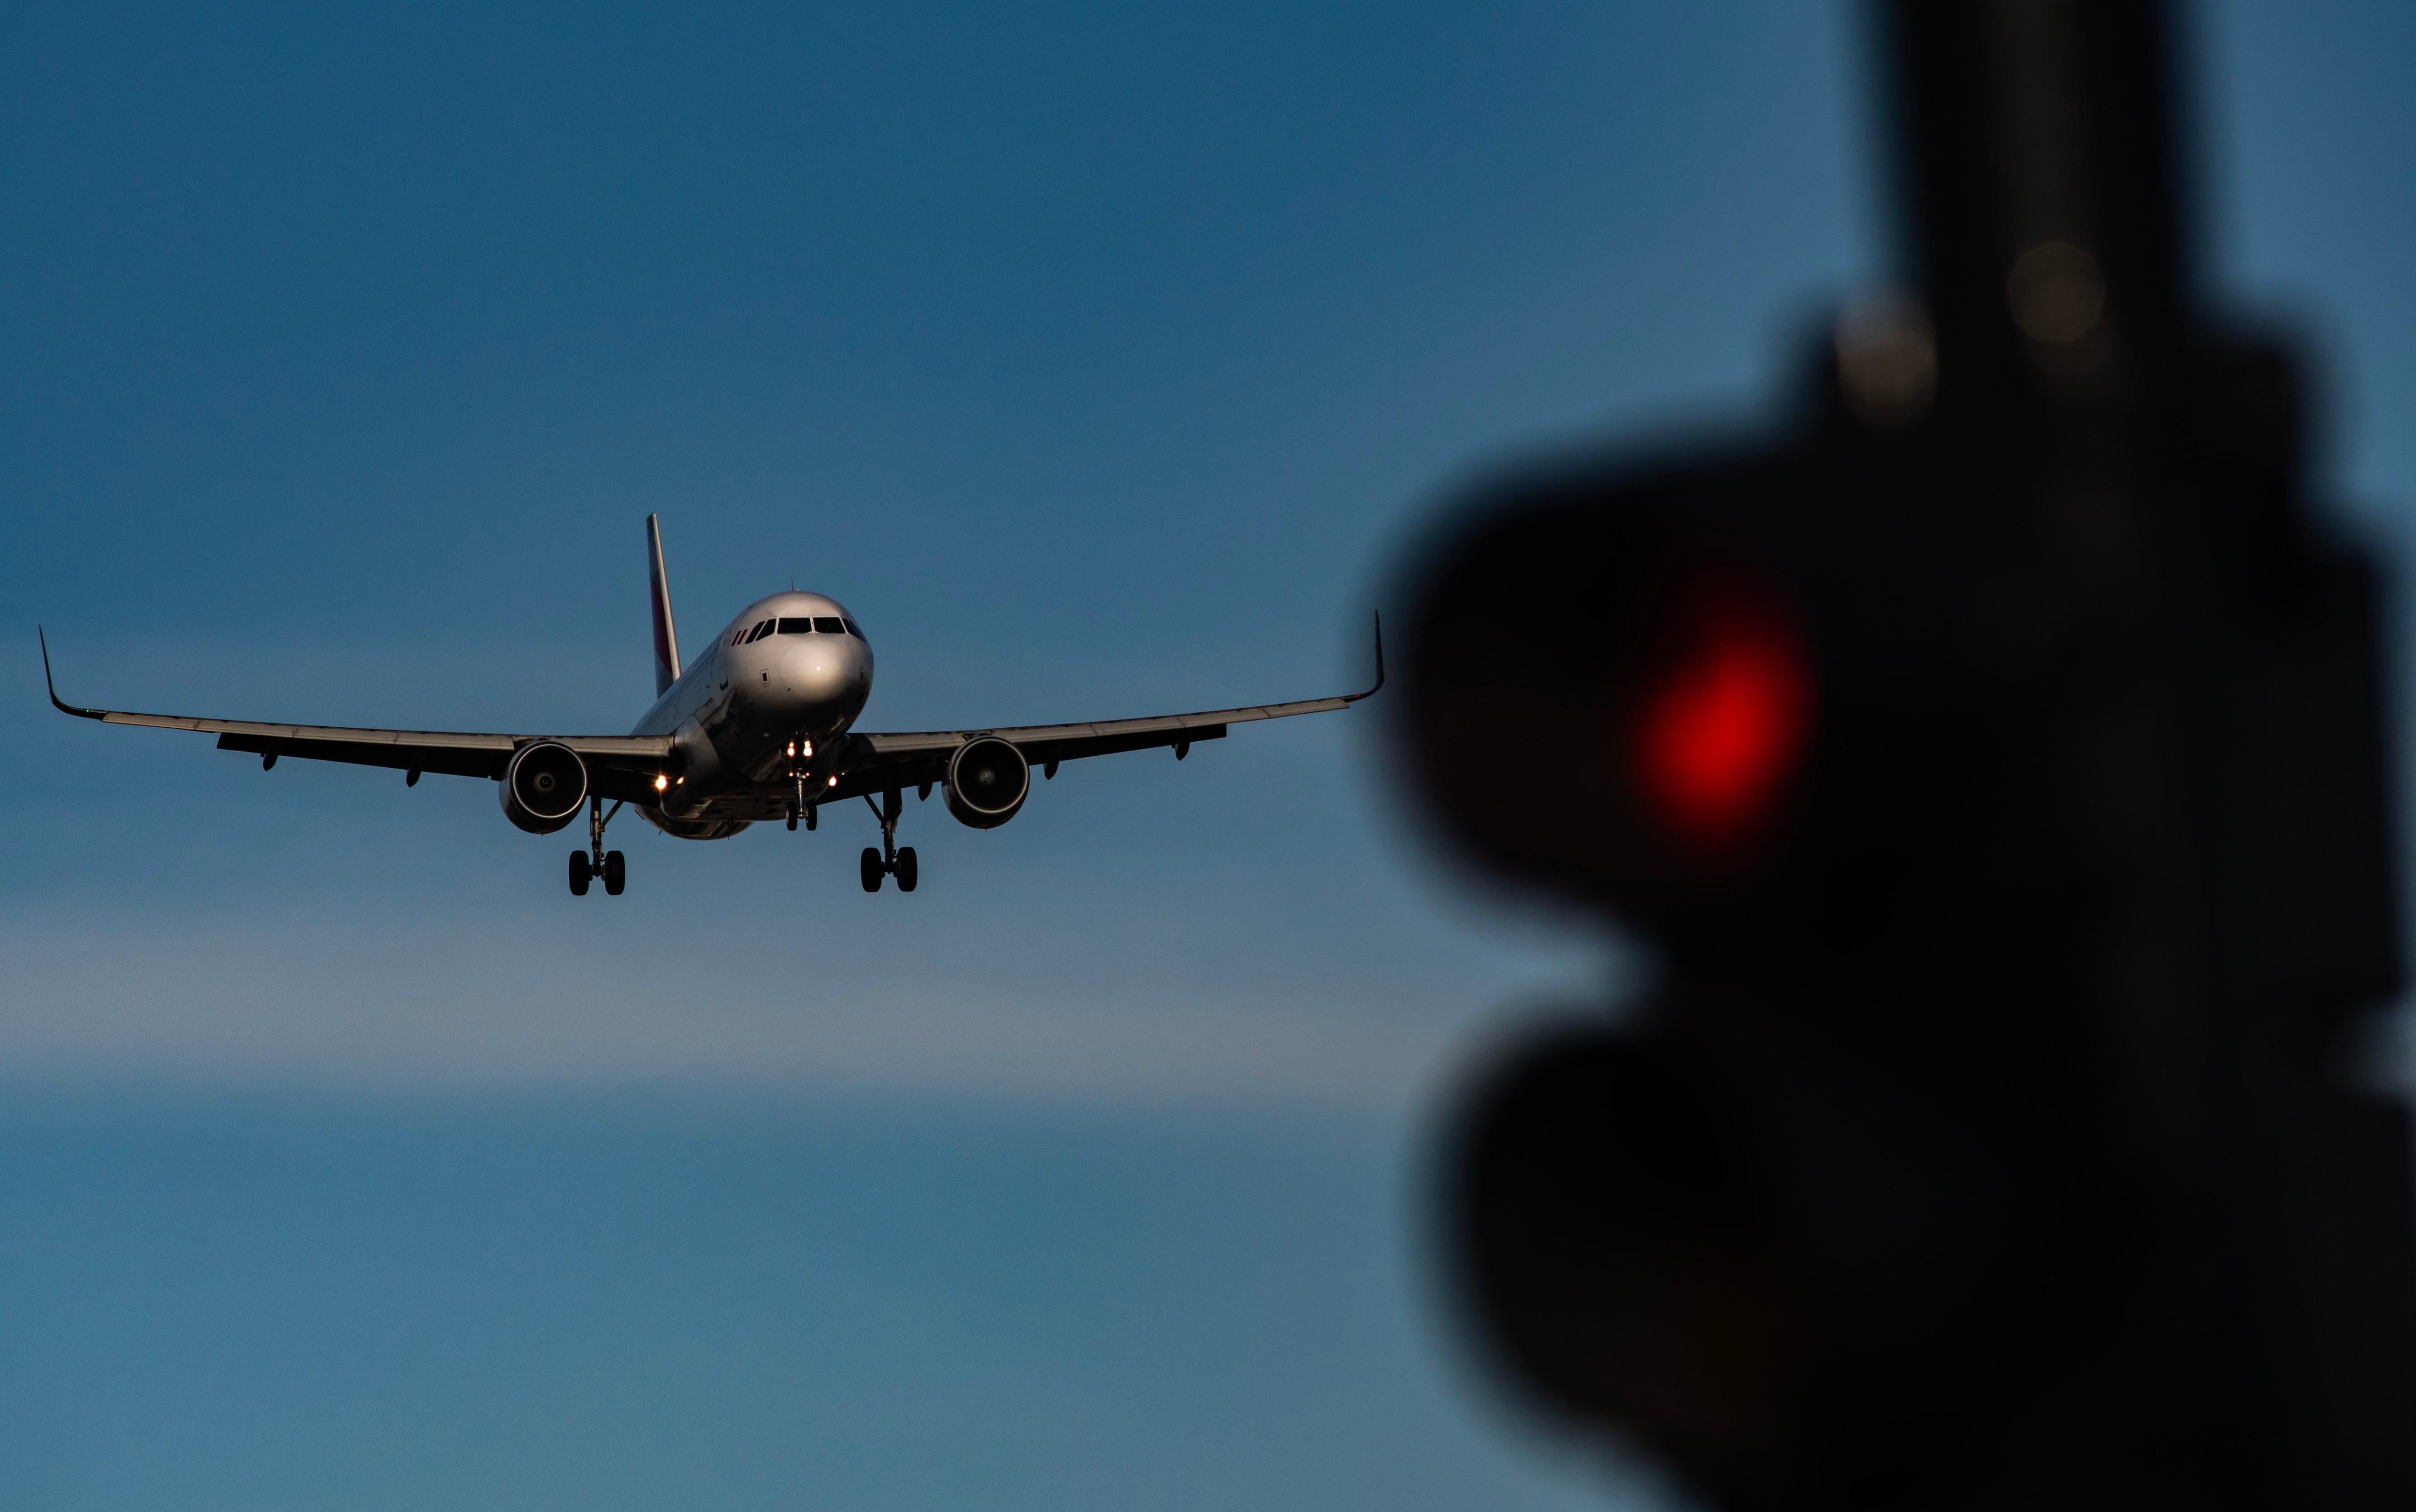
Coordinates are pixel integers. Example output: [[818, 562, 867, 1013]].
[[36, 515, 1384, 898]]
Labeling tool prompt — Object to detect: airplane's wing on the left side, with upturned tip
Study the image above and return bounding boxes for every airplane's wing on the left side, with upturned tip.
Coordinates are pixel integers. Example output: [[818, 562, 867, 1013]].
[[41, 638, 672, 802]]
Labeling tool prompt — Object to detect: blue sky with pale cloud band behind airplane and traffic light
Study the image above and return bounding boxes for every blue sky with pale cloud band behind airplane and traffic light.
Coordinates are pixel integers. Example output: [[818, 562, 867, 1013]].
[[0, 0, 2416, 1510]]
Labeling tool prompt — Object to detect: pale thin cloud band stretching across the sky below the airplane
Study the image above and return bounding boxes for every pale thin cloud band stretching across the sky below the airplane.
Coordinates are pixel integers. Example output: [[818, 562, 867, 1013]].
[[0, 915, 1457, 1111]]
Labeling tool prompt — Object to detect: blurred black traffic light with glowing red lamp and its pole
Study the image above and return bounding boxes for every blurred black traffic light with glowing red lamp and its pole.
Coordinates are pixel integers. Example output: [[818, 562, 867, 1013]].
[[1396, 0, 2416, 1510]]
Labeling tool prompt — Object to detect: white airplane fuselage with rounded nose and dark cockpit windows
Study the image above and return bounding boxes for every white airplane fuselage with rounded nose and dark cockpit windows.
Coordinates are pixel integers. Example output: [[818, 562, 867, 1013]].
[[631, 592, 872, 840]]
